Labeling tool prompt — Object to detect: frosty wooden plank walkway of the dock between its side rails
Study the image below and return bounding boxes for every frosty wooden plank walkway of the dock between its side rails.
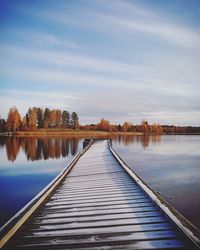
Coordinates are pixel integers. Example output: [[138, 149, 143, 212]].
[[0, 141, 198, 250]]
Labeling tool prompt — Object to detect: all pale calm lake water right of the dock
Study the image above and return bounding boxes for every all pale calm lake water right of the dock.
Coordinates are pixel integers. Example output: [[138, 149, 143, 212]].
[[113, 135, 200, 228]]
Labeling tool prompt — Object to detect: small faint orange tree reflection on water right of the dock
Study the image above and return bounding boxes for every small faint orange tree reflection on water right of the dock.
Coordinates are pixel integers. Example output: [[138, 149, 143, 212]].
[[113, 135, 161, 149]]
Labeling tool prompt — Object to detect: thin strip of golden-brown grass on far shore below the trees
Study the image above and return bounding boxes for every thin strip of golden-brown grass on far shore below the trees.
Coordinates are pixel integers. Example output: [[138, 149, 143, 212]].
[[1, 129, 143, 138]]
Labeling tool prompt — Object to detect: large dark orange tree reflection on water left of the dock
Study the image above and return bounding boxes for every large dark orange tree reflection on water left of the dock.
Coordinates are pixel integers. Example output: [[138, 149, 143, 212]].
[[0, 137, 80, 162]]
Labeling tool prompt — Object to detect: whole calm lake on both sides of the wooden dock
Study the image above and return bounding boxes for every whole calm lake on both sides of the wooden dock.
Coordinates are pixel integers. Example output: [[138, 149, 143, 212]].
[[0, 135, 200, 227]]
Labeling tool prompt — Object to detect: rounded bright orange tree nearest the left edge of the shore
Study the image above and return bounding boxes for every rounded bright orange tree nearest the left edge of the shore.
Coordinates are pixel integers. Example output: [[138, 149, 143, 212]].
[[7, 107, 21, 132]]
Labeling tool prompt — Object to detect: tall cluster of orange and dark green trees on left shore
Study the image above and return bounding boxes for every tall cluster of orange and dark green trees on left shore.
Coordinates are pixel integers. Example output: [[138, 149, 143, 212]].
[[0, 107, 79, 132]]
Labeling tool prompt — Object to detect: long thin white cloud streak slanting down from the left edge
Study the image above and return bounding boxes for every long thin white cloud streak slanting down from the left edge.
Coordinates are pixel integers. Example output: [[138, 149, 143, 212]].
[[0, 45, 147, 74]]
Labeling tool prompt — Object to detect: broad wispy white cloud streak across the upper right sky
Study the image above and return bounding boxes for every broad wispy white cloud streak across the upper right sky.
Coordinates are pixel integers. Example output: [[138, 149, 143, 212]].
[[37, 1, 200, 49]]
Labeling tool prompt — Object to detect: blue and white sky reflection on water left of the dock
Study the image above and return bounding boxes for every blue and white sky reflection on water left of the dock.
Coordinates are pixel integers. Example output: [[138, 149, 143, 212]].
[[0, 139, 82, 226]]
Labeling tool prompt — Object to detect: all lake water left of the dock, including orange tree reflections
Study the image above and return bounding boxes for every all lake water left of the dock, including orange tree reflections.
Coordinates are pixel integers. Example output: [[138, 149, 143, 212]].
[[0, 137, 83, 227]]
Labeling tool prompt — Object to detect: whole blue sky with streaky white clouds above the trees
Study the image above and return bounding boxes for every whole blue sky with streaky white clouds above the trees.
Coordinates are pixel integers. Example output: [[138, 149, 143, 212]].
[[0, 0, 200, 126]]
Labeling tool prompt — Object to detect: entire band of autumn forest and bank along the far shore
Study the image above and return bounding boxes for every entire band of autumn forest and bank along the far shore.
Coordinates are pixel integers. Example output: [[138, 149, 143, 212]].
[[0, 107, 200, 134]]
